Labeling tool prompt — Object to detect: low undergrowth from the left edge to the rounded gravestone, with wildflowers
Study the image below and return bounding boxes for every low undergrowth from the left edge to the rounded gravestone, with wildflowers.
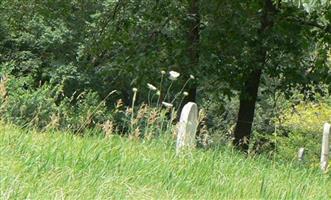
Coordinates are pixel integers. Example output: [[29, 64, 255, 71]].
[[0, 70, 192, 139]]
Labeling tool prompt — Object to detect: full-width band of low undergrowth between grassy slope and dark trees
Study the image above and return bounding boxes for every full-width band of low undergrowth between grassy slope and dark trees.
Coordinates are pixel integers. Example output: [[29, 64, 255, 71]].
[[0, 70, 331, 167]]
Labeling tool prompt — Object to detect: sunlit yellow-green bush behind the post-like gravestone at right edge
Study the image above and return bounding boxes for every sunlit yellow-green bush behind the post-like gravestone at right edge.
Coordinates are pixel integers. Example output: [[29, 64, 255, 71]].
[[275, 102, 331, 164]]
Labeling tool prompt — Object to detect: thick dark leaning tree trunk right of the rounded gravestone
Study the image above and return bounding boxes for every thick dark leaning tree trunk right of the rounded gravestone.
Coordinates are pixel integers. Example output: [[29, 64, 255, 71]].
[[233, 0, 277, 152]]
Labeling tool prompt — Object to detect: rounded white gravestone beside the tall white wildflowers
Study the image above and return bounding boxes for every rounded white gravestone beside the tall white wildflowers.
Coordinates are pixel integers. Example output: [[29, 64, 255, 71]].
[[176, 102, 198, 154]]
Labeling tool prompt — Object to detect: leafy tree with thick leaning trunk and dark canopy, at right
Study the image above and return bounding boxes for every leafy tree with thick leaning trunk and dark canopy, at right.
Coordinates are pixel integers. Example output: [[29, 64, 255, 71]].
[[202, 0, 330, 150]]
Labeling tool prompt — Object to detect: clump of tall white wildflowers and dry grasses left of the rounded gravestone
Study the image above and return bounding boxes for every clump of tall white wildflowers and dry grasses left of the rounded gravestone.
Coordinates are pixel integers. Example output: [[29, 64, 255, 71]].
[[102, 71, 194, 139]]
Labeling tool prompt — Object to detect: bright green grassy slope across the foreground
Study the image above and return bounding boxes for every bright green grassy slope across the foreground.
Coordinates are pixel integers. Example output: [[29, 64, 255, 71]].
[[0, 122, 331, 199]]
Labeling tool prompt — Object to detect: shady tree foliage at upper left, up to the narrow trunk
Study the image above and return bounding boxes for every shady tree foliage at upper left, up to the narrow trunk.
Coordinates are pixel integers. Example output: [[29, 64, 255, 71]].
[[0, 0, 192, 104]]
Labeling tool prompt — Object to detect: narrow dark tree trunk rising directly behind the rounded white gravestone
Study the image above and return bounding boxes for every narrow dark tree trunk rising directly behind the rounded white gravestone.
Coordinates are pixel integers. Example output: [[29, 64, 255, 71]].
[[184, 0, 200, 105]]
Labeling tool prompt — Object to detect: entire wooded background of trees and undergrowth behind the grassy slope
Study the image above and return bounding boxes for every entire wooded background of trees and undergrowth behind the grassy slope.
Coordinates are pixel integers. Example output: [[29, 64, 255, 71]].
[[0, 0, 331, 166]]
